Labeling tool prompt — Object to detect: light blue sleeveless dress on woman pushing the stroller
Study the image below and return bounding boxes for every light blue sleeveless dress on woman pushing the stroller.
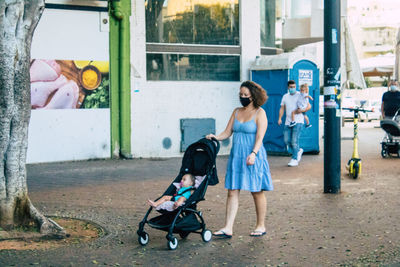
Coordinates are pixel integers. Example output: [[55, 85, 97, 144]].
[[225, 112, 274, 192]]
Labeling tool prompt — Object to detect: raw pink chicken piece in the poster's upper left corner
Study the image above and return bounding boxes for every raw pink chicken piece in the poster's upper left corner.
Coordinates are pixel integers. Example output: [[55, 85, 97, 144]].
[[30, 59, 61, 82]]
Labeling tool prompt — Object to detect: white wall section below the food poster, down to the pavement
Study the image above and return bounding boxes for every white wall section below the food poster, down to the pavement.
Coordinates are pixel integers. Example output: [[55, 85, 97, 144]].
[[27, 109, 110, 163]]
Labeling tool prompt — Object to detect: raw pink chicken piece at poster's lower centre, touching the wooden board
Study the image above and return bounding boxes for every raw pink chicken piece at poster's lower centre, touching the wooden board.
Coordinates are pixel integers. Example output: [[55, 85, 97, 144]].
[[43, 80, 79, 109]]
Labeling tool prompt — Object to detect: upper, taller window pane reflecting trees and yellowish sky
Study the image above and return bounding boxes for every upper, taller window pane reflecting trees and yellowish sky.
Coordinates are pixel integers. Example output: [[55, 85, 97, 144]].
[[145, 0, 239, 45]]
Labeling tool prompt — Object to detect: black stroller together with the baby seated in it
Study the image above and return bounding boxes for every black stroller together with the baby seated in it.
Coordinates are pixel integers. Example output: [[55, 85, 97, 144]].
[[137, 138, 220, 250]]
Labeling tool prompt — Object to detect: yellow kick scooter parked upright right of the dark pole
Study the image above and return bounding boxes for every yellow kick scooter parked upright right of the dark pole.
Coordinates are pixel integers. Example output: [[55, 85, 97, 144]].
[[342, 107, 371, 179]]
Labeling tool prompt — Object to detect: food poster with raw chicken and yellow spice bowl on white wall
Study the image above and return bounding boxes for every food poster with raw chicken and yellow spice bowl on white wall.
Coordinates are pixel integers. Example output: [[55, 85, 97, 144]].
[[30, 59, 110, 109]]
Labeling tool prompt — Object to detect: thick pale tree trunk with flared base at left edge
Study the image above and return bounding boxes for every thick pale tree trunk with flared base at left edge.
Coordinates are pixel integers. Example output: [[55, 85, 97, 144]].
[[0, 0, 65, 239]]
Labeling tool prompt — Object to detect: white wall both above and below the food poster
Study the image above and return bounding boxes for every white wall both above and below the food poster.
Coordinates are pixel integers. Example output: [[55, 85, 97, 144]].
[[27, 9, 110, 163]]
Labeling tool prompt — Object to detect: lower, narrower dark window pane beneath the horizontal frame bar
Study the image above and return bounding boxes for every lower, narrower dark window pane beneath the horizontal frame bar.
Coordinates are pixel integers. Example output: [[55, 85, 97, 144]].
[[147, 53, 240, 81]]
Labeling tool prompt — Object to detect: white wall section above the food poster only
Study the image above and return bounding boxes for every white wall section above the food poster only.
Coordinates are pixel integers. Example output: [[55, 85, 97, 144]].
[[31, 9, 109, 61]]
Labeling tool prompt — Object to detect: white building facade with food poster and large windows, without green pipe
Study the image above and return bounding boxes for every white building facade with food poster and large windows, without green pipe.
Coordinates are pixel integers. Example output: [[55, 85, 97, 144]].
[[28, 0, 281, 163]]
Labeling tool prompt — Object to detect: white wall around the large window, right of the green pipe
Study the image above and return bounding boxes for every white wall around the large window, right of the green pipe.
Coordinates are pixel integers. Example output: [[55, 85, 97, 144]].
[[131, 0, 260, 157]]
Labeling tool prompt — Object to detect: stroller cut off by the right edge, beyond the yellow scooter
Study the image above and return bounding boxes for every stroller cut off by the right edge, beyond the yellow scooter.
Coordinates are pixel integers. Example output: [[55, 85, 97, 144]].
[[381, 109, 400, 158]]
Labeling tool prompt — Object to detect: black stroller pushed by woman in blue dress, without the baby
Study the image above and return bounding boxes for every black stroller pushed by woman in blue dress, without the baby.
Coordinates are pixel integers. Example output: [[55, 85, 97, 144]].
[[137, 138, 220, 250]]
